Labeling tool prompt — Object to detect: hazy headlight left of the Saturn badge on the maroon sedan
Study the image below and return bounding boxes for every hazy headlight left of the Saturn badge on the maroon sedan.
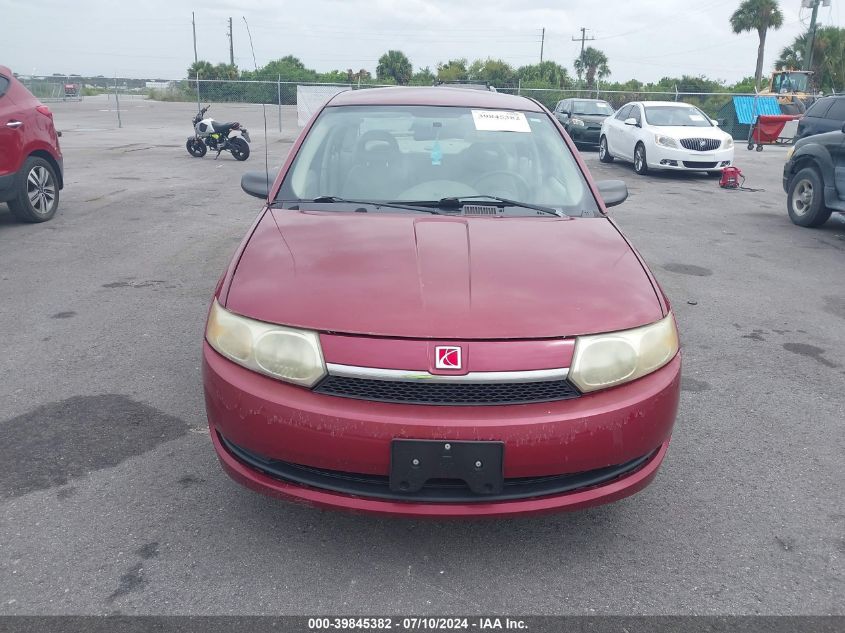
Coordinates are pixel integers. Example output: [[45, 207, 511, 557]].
[[205, 299, 326, 387]]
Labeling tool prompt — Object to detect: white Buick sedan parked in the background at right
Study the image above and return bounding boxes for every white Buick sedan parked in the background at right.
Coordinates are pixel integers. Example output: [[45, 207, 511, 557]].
[[599, 101, 734, 174]]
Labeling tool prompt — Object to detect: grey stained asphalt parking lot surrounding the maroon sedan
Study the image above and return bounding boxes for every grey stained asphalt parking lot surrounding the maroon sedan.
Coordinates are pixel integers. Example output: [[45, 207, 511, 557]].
[[0, 98, 845, 614]]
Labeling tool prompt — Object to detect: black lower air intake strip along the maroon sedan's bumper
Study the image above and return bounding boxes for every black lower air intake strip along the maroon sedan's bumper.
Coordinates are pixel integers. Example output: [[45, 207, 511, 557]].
[[217, 433, 659, 503]]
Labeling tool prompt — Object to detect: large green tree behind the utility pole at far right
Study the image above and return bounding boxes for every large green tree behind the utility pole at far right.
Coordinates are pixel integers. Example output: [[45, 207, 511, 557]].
[[775, 26, 845, 92]]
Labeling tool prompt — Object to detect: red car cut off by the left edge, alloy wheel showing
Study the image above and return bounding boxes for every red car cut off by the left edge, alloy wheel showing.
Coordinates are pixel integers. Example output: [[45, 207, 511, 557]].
[[0, 66, 64, 222]]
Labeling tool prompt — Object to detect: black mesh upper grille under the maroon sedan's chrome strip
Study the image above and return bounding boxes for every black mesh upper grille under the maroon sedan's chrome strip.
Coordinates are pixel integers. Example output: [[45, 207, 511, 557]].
[[314, 376, 580, 406]]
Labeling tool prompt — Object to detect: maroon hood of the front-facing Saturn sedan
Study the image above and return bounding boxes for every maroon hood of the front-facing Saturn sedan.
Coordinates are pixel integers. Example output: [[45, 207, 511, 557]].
[[225, 210, 663, 339]]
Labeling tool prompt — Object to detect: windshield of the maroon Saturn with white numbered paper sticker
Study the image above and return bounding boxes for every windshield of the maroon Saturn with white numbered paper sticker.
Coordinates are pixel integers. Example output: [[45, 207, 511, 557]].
[[276, 105, 599, 216]]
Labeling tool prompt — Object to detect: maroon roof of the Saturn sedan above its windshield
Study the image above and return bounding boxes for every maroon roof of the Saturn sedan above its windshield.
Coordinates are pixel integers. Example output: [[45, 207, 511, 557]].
[[326, 86, 543, 112]]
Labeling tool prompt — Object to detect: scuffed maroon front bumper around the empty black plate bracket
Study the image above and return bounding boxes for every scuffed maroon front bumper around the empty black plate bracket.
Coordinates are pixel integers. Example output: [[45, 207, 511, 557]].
[[203, 343, 681, 517]]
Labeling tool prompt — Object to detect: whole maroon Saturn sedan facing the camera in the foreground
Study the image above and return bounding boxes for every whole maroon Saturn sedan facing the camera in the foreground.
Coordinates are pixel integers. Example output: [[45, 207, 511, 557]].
[[203, 87, 681, 517]]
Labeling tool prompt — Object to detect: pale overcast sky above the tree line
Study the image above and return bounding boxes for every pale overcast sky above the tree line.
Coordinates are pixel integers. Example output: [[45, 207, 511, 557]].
[[0, 0, 845, 83]]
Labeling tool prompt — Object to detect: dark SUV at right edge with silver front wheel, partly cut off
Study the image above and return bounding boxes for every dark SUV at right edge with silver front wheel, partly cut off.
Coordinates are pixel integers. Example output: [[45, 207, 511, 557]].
[[783, 125, 845, 227]]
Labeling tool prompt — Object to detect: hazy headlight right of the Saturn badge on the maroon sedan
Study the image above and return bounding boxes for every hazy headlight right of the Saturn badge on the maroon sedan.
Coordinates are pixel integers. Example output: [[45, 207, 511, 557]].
[[569, 312, 679, 392]]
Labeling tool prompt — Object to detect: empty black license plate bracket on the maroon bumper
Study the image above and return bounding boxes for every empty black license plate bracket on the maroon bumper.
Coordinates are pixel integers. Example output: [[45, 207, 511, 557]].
[[390, 439, 505, 495]]
